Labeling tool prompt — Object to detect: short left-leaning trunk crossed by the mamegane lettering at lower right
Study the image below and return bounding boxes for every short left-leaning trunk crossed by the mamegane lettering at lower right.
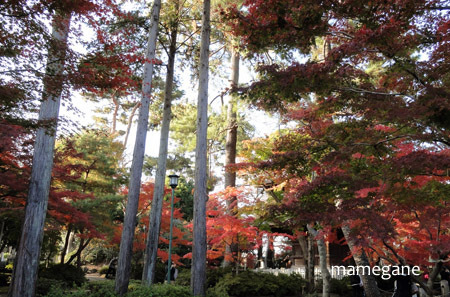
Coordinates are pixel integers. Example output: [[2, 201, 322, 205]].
[[342, 224, 381, 297]]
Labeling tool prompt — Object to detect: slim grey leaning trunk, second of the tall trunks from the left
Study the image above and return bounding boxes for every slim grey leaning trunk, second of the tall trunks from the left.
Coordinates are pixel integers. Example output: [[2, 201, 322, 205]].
[[115, 0, 161, 295]]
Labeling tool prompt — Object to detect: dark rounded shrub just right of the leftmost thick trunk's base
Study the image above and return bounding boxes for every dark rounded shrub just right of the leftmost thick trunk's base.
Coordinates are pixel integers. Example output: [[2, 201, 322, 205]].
[[39, 264, 86, 288]]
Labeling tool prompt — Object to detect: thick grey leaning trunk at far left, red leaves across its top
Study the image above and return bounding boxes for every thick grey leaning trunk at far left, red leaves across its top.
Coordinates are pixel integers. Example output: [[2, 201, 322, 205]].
[[9, 12, 71, 297]]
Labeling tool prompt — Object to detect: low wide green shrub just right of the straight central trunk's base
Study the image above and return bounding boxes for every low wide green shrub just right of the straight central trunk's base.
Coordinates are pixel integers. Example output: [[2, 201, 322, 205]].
[[208, 271, 304, 297]]
